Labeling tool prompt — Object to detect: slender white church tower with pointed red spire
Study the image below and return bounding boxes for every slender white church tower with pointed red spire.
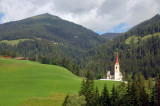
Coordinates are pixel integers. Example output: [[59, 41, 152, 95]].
[[114, 52, 120, 80]]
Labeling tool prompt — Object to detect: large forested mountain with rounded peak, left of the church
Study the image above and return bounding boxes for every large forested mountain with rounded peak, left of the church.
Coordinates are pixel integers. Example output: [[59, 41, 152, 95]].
[[0, 13, 105, 58]]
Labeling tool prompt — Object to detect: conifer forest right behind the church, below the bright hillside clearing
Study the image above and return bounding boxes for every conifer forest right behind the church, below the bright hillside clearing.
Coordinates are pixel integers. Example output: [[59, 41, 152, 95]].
[[85, 35, 160, 79]]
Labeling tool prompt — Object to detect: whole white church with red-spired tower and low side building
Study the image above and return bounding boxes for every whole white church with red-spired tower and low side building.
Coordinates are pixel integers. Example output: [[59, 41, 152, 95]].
[[107, 52, 123, 81]]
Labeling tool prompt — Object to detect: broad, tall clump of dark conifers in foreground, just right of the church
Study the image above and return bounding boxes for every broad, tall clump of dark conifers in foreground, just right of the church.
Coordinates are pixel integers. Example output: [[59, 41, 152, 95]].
[[122, 73, 149, 106]]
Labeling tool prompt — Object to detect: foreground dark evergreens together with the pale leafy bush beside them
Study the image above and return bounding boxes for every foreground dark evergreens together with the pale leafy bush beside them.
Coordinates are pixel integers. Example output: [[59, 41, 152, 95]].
[[63, 73, 160, 106]]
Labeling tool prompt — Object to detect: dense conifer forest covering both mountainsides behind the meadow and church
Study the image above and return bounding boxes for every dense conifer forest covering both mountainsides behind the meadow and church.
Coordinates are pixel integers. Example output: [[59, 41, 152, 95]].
[[0, 14, 160, 79]]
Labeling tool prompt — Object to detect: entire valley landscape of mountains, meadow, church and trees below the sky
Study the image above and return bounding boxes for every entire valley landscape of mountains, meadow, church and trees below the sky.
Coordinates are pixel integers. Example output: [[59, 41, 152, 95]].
[[0, 13, 160, 106]]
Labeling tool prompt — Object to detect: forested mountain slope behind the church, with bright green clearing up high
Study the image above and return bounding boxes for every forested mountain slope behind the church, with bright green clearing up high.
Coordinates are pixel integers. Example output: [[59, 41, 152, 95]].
[[85, 15, 160, 79]]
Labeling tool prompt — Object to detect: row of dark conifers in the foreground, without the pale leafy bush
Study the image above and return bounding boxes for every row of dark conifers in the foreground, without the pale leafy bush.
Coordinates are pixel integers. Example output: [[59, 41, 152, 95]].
[[72, 72, 160, 106]]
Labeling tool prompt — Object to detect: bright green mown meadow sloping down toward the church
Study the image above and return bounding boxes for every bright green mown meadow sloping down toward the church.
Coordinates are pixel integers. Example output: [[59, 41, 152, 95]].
[[0, 58, 120, 106]]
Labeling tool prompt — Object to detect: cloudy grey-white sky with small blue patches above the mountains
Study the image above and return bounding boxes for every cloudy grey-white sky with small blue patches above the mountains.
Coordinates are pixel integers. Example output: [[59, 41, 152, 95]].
[[0, 0, 160, 33]]
